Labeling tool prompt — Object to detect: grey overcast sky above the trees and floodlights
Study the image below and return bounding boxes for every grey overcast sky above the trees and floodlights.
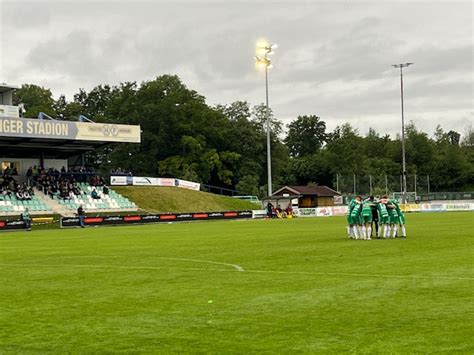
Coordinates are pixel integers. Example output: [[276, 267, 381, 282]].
[[0, 0, 474, 135]]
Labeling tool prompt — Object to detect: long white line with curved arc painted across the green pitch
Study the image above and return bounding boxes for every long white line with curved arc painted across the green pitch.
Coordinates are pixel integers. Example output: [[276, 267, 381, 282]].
[[0, 259, 474, 281]]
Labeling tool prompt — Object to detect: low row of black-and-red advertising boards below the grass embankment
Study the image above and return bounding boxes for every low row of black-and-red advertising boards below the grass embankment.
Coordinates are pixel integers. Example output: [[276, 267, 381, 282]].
[[61, 211, 252, 229]]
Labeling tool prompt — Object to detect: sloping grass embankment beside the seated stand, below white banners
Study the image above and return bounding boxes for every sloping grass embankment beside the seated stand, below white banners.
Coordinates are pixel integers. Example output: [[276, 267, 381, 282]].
[[113, 186, 259, 213]]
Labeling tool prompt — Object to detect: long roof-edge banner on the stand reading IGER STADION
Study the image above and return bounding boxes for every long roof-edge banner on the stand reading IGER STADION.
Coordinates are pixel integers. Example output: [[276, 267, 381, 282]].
[[0, 116, 141, 143]]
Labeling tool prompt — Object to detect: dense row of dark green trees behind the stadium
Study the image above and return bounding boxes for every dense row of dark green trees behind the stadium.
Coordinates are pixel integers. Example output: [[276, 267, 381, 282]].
[[14, 75, 474, 196]]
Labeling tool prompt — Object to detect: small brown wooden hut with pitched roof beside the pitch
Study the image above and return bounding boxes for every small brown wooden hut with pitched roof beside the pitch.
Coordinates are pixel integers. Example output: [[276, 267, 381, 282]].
[[269, 186, 342, 208]]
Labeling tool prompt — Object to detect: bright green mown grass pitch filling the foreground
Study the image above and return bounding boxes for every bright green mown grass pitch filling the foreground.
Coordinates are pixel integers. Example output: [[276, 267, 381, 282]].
[[0, 212, 474, 354]]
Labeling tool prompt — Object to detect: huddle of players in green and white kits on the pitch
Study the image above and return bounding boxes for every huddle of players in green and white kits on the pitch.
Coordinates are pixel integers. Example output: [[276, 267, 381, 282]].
[[347, 196, 406, 240]]
